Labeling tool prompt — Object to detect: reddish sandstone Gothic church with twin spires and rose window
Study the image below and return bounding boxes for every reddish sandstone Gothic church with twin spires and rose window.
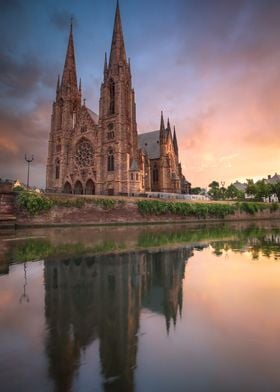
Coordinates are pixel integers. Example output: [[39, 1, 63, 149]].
[[46, 4, 190, 195]]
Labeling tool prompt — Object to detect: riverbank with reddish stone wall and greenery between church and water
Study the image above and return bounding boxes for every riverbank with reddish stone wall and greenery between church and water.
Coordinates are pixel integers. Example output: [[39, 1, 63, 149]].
[[15, 195, 280, 227]]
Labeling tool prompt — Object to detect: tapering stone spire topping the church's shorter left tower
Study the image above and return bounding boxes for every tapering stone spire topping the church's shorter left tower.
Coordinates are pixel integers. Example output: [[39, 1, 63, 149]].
[[61, 19, 77, 89]]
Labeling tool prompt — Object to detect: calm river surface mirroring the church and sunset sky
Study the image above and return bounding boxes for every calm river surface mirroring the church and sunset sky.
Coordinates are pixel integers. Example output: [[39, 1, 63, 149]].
[[0, 222, 280, 392]]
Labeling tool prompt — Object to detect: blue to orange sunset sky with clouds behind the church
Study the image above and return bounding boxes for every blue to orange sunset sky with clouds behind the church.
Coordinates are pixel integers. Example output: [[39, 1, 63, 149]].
[[0, 0, 280, 187]]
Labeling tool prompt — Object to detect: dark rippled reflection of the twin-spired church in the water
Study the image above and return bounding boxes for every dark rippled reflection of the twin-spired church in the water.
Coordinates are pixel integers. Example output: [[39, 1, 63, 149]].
[[45, 249, 192, 391]]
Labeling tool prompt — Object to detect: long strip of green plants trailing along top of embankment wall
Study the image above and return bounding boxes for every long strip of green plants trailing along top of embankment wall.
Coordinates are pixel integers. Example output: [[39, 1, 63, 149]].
[[16, 191, 279, 219]]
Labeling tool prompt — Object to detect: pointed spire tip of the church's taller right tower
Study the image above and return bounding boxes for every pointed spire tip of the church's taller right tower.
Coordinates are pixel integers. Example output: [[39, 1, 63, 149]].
[[109, 1, 126, 67]]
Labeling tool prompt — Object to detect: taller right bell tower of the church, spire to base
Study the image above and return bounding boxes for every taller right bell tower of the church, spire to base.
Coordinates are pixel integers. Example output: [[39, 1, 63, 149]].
[[98, 3, 138, 194]]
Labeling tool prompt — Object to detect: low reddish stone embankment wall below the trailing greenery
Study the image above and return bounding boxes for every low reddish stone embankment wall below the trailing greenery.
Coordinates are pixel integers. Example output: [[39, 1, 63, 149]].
[[17, 202, 280, 225]]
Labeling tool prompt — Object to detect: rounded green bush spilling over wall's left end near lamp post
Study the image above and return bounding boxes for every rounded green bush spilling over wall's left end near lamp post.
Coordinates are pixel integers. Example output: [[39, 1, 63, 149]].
[[16, 191, 54, 215]]
